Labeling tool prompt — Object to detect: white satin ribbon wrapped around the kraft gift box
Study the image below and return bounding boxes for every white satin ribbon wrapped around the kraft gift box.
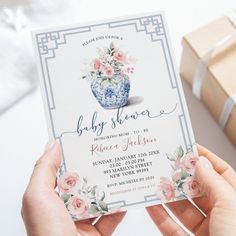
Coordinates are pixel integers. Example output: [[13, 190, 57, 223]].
[[192, 12, 236, 129]]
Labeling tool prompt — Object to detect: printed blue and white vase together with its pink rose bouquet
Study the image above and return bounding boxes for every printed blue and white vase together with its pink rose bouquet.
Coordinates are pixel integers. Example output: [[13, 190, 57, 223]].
[[82, 42, 134, 109]]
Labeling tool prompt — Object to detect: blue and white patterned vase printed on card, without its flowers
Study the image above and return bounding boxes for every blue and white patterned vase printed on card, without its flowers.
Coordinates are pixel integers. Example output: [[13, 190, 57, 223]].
[[91, 71, 130, 109]]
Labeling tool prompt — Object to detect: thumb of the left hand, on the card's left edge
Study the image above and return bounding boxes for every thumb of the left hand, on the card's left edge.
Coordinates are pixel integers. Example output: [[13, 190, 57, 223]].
[[28, 140, 61, 191]]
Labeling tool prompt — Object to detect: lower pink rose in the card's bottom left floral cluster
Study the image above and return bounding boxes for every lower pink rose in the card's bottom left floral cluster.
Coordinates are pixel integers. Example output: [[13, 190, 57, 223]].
[[67, 196, 90, 217]]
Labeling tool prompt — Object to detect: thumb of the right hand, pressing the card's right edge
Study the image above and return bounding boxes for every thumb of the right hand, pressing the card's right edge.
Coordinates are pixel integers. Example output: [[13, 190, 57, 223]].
[[196, 156, 235, 205]]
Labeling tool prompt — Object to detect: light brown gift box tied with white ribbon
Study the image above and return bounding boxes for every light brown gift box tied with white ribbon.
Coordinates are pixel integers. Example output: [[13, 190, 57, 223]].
[[180, 12, 236, 146]]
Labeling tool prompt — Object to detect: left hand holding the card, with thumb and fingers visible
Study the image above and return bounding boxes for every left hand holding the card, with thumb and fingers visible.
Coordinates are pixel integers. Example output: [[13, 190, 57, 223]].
[[21, 141, 125, 236]]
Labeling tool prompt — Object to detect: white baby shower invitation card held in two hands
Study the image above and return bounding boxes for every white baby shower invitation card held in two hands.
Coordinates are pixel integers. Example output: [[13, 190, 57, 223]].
[[33, 12, 200, 220]]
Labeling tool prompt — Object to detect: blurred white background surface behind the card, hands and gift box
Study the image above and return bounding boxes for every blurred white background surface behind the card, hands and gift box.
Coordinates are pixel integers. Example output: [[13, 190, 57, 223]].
[[0, 0, 236, 236]]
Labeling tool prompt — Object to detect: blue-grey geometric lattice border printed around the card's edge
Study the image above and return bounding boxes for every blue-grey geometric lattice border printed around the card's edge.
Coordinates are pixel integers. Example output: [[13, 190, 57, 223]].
[[36, 14, 194, 206]]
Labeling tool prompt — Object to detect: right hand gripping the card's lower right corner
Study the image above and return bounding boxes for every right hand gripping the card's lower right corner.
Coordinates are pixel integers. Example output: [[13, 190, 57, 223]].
[[147, 145, 236, 236]]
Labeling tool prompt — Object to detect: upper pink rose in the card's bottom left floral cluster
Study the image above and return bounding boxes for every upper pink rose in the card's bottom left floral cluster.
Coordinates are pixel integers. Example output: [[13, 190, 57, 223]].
[[57, 172, 79, 193]]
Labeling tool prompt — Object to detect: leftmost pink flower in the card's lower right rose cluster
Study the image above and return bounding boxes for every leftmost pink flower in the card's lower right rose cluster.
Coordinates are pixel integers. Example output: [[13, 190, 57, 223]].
[[156, 177, 175, 201]]
